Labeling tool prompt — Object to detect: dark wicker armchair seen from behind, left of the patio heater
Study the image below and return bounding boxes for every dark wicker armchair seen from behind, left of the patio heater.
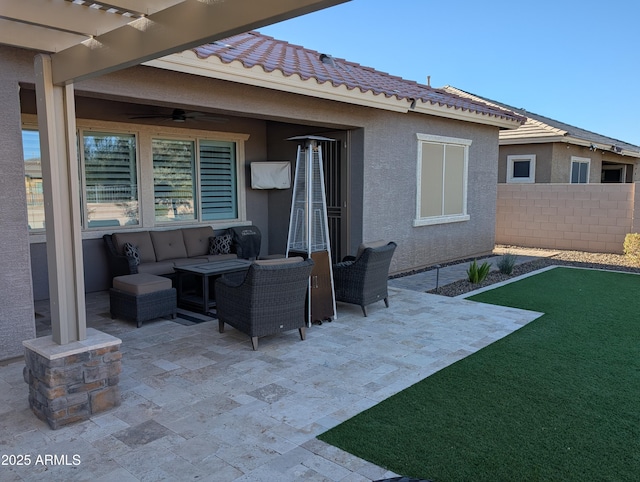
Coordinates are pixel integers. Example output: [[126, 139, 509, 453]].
[[215, 258, 313, 350]]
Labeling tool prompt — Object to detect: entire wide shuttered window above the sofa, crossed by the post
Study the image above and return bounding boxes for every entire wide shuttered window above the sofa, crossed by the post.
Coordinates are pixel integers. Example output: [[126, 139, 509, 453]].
[[22, 120, 249, 239]]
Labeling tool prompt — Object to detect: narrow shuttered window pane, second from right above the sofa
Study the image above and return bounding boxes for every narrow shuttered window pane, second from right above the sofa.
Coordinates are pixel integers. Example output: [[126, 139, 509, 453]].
[[152, 139, 196, 221]]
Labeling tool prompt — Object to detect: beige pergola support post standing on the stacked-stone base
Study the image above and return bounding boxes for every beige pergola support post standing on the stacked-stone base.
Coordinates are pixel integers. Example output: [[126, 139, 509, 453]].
[[35, 55, 87, 345]]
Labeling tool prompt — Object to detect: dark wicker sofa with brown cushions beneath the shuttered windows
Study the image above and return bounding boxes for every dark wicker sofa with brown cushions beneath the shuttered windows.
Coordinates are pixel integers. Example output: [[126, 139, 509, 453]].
[[103, 226, 238, 277]]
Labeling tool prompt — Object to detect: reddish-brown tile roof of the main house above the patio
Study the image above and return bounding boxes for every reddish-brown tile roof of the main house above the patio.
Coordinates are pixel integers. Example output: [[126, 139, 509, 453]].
[[193, 31, 524, 123]]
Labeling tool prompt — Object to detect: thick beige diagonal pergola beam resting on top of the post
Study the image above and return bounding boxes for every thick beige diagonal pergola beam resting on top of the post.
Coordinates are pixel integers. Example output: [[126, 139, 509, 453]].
[[52, 0, 347, 85]]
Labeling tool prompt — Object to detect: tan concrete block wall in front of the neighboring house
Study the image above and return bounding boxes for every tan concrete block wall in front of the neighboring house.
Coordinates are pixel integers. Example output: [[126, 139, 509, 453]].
[[496, 184, 640, 253]]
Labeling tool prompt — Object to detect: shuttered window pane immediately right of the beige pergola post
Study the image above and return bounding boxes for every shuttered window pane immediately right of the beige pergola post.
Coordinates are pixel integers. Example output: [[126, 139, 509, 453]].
[[81, 131, 140, 228]]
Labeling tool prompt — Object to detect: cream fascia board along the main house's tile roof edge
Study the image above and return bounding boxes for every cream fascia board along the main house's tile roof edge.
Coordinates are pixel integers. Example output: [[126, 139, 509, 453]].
[[144, 51, 520, 129]]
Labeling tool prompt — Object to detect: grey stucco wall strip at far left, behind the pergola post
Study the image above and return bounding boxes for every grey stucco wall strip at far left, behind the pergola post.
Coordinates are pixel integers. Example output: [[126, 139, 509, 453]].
[[0, 49, 35, 360]]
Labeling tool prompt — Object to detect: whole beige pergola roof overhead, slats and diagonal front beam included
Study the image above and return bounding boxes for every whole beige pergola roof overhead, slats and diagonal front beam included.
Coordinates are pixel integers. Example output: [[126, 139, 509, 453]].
[[0, 0, 348, 85]]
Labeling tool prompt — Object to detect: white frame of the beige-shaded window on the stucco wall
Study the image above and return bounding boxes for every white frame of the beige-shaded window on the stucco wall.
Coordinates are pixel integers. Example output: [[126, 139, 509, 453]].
[[413, 134, 472, 227]]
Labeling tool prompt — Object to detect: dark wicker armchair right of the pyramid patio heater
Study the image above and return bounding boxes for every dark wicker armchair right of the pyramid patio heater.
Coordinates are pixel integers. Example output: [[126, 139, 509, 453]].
[[333, 242, 397, 316]]
